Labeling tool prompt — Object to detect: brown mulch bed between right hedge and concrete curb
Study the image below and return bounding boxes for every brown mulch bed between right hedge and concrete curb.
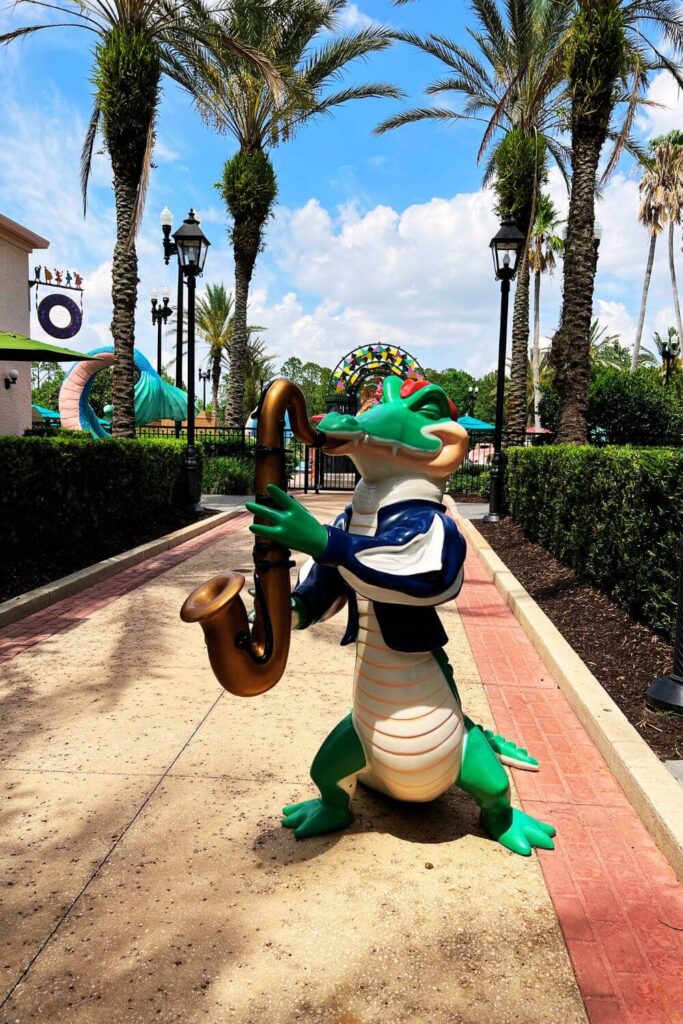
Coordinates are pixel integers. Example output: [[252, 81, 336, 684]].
[[476, 518, 683, 761]]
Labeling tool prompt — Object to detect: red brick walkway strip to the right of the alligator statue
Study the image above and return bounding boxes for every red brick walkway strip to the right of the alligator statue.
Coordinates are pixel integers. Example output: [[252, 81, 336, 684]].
[[458, 552, 683, 1024]]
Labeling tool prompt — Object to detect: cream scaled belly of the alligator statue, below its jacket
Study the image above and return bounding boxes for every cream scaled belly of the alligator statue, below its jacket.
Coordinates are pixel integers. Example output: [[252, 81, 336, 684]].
[[353, 595, 464, 801]]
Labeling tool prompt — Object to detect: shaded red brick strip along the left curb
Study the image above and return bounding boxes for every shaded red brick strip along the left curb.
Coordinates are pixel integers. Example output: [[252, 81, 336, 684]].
[[0, 513, 251, 665]]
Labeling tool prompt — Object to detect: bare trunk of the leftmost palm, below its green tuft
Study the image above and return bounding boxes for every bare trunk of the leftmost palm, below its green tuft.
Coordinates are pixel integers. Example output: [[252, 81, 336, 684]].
[[112, 168, 138, 437]]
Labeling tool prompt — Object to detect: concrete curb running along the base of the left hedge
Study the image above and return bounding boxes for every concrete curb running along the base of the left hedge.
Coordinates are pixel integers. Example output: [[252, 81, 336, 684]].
[[0, 505, 245, 627]]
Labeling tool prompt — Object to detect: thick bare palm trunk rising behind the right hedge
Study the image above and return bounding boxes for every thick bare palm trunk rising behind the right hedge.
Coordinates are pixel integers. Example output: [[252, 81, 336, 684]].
[[550, 126, 602, 444]]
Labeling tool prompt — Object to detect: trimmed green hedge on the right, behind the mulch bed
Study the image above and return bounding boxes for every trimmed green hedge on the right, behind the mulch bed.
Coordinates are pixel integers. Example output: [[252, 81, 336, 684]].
[[507, 444, 683, 640]]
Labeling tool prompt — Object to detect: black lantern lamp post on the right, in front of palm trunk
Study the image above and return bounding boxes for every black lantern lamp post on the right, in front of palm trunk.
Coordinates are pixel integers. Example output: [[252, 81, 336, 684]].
[[482, 217, 526, 522]]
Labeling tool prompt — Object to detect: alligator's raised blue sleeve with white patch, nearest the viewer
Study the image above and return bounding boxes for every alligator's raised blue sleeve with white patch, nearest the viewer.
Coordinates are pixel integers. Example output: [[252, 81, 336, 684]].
[[319, 506, 466, 604]]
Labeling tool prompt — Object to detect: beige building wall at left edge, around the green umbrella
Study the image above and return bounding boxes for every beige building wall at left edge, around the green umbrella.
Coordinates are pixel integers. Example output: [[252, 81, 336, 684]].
[[0, 214, 49, 434]]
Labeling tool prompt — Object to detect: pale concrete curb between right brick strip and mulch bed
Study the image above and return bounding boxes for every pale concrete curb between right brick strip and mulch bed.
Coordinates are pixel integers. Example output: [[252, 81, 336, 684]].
[[446, 502, 683, 881]]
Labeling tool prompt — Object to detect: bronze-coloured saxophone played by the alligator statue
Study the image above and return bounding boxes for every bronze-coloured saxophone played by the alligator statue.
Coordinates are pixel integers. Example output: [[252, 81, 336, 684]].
[[180, 378, 326, 697]]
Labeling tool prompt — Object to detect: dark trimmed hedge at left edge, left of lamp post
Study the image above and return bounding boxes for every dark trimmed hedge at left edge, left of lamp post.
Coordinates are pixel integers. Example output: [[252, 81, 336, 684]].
[[0, 434, 197, 599]]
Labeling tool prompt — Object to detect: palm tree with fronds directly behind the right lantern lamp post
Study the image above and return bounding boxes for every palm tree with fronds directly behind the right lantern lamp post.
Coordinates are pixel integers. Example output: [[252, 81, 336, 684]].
[[376, 0, 569, 448]]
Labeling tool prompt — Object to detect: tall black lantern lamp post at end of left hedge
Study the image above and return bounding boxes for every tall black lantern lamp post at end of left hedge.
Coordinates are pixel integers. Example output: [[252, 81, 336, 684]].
[[162, 210, 211, 513]]
